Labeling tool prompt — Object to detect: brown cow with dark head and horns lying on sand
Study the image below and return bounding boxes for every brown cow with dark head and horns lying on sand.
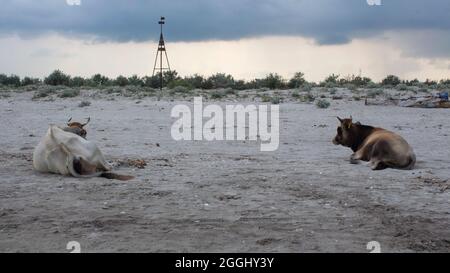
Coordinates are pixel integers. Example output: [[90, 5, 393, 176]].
[[333, 117, 416, 170]]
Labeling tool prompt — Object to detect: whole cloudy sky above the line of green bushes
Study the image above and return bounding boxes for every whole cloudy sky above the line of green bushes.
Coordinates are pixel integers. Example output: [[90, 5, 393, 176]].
[[0, 0, 450, 81]]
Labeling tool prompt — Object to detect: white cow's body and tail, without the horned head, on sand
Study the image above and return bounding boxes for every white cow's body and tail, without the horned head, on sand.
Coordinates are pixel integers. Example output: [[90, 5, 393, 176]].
[[33, 122, 133, 180]]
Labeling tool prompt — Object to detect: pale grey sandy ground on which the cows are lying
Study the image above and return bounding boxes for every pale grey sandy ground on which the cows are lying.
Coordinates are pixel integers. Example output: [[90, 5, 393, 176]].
[[0, 90, 450, 252]]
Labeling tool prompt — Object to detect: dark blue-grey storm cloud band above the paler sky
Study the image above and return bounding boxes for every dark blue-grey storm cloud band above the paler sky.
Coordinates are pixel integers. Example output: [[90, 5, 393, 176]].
[[0, 0, 450, 44]]
